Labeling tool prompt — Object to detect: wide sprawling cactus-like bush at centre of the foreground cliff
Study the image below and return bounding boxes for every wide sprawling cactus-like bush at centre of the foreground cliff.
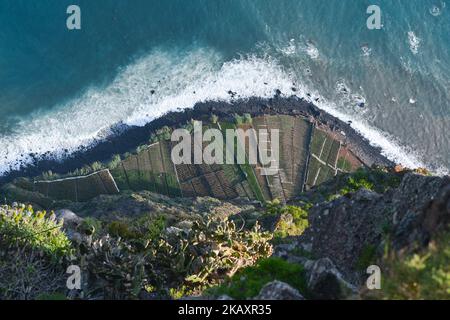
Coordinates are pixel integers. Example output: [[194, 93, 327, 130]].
[[71, 211, 272, 299]]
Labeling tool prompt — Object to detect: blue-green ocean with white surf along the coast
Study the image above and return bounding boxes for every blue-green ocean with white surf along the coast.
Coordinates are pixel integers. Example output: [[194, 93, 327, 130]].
[[0, 0, 450, 174]]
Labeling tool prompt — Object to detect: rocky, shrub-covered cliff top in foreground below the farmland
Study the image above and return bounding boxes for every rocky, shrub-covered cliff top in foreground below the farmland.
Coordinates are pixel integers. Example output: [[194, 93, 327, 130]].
[[0, 168, 450, 299]]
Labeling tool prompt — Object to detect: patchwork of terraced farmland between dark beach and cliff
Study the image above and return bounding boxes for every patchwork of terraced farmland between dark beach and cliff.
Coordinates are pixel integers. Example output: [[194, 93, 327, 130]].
[[19, 115, 363, 202]]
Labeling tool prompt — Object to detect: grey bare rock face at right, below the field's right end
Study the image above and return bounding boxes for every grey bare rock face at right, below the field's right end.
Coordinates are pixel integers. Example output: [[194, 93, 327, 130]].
[[282, 173, 450, 285]]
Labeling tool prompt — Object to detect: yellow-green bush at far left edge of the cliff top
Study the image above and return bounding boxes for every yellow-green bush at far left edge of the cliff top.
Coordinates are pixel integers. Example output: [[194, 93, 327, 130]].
[[0, 205, 72, 300]]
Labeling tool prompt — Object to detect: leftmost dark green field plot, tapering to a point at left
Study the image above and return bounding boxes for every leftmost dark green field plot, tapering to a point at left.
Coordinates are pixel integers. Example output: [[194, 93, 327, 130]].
[[34, 169, 119, 201]]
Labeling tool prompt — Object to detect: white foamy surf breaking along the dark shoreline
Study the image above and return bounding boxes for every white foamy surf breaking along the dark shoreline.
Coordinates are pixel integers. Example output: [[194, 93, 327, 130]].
[[0, 49, 436, 174]]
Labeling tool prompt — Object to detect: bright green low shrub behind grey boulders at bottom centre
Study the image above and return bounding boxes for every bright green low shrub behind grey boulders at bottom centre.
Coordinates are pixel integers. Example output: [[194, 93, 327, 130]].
[[210, 257, 307, 299]]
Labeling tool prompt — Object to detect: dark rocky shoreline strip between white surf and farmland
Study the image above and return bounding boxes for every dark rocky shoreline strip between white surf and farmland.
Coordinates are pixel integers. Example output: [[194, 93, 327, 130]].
[[0, 95, 395, 185]]
